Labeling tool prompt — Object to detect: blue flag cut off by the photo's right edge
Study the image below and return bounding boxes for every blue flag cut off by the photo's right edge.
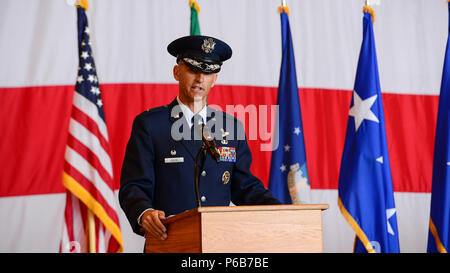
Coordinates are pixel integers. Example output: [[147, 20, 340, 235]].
[[427, 3, 450, 253]]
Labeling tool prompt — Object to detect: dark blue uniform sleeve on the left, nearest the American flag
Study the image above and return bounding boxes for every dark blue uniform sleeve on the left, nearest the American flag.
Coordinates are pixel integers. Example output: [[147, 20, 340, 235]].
[[119, 115, 155, 235]]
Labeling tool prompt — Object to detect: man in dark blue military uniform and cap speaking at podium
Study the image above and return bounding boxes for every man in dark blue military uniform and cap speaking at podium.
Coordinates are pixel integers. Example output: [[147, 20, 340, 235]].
[[119, 36, 280, 240]]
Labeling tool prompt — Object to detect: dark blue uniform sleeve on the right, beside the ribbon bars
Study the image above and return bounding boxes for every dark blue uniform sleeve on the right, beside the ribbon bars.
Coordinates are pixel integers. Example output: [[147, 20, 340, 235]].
[[231, 121, 281, 205]]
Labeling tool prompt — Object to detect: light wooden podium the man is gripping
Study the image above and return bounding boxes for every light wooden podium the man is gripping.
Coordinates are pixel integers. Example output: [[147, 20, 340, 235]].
[[145, 204, 328, 253]]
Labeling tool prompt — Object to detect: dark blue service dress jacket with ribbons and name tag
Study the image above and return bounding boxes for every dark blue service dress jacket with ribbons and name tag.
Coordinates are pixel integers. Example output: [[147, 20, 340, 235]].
[[119, 99, 281, 235]]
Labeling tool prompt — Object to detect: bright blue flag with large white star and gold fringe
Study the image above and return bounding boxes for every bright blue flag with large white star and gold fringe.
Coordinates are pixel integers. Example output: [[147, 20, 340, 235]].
[[338, 9, 399, 253]]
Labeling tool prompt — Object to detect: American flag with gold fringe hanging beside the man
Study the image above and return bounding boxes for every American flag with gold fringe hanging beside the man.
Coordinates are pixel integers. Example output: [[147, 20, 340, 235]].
[[60, 7, 123, 252]]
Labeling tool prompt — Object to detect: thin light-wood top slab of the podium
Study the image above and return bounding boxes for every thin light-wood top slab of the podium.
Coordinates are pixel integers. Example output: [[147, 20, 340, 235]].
[[162, 204, 329, 224]]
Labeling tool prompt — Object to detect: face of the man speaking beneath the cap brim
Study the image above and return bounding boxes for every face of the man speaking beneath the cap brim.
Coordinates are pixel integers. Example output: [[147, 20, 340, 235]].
[[173, 62, 217, 108]]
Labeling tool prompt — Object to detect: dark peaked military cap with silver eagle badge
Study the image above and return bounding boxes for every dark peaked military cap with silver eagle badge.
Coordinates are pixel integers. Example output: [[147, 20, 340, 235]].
[[167, 35, 232, 73]]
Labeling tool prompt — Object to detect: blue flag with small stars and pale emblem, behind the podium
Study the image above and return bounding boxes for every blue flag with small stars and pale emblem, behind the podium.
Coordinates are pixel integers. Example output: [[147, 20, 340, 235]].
[[269, 7, 310, 204]]
